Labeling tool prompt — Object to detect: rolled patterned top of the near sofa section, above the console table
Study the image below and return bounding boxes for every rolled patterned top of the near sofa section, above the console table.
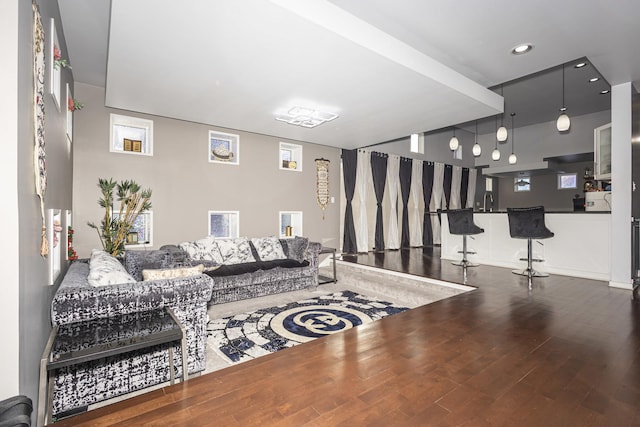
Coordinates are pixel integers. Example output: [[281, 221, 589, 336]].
[[51, 262, 213, 325]]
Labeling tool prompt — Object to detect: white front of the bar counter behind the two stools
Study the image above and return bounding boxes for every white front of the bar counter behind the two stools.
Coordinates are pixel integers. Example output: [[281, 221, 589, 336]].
[[441, 211, 611, 281]]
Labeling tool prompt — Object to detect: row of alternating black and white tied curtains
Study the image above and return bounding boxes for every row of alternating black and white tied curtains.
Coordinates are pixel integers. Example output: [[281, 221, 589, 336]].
[[342, 150, 476, 253]]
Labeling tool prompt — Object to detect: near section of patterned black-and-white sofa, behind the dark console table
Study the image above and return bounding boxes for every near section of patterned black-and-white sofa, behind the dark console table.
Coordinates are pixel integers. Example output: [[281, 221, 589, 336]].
[[51, 251, 213, 416]]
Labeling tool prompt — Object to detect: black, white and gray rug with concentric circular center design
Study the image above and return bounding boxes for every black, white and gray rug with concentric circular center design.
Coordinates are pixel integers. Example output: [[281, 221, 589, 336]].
[[208, 291, 409, 363]]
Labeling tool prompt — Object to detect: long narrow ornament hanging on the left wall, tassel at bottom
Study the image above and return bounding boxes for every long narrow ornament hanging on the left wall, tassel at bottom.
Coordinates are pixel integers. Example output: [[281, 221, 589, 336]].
[[31, 2, 49, 256]]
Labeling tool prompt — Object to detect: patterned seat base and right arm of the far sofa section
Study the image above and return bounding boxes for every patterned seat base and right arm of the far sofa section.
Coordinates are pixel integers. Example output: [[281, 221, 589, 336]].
[[161, 237, 321, 305]]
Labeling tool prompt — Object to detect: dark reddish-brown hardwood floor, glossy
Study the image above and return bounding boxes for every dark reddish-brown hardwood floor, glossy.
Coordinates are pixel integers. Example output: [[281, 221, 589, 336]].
[[58, 248, 640, 427]]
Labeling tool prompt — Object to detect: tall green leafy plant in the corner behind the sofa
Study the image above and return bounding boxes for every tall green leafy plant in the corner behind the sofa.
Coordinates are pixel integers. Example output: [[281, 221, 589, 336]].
[[87, 178, 151, 256]]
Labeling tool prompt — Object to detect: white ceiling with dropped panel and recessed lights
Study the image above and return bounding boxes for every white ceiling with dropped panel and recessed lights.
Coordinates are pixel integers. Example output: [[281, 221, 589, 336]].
[[58, 0, 640, 148]]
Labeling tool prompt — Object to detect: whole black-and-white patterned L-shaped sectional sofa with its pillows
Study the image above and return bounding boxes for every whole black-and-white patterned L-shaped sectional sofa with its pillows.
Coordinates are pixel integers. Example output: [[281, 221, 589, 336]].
[[51, 237, 320, 415]]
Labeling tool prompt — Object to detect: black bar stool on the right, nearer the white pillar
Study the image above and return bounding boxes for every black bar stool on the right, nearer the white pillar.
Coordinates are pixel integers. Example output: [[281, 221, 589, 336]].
[[507, 206, 554, 279]]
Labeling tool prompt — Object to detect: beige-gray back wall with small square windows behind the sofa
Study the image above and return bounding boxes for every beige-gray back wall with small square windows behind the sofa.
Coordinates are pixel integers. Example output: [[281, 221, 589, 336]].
[[73, 84, 340, 257]]
